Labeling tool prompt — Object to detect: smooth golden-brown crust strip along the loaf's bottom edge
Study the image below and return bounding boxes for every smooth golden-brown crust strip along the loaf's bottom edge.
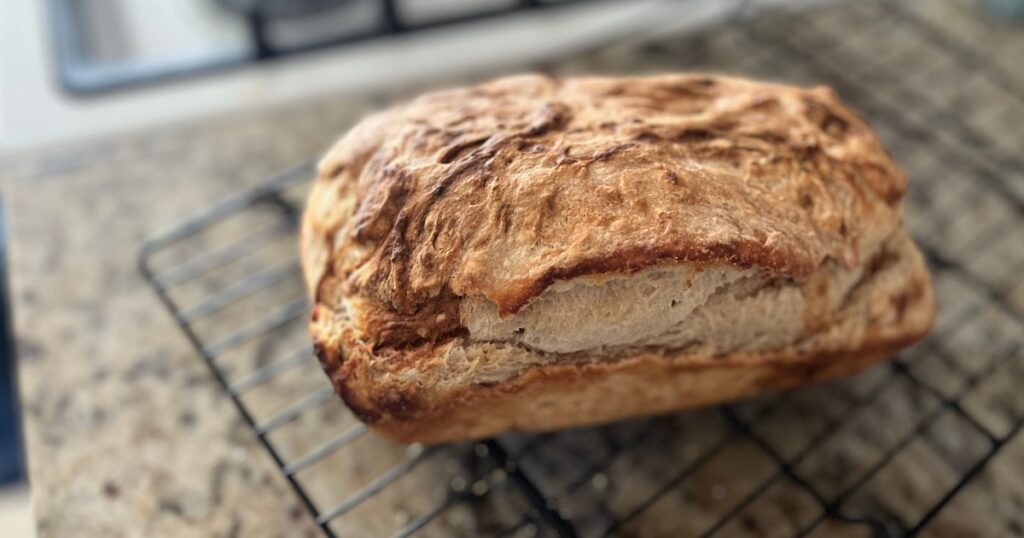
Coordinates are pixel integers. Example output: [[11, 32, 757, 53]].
[[356, 338, 916, 444]]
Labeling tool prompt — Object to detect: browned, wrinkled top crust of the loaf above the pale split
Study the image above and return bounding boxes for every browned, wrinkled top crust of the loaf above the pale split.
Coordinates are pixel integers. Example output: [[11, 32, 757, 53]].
[[302, 75, 906, 344]]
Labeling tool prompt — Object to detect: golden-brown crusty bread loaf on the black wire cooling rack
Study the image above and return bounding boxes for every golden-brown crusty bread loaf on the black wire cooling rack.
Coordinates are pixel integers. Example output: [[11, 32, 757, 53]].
[[301, 75, 935, 443]]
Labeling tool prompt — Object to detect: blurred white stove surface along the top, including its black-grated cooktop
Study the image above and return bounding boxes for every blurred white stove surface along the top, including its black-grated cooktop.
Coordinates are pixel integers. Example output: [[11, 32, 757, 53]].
[[0, 0, 753, 149]]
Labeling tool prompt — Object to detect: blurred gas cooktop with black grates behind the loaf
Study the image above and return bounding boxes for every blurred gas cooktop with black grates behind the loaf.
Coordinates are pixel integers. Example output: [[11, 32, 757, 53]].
[[49, 0, 598, 92]]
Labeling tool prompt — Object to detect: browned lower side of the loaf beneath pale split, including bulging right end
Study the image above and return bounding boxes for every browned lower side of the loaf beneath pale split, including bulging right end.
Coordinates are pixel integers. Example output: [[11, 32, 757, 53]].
[[314, 226, 935, 443]]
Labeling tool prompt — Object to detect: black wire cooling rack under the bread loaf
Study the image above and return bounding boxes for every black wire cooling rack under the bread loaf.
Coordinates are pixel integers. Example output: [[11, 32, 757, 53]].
[[140, 0, 1024, 536]]
